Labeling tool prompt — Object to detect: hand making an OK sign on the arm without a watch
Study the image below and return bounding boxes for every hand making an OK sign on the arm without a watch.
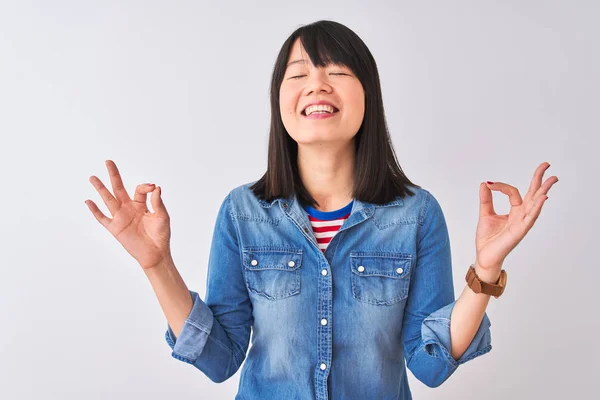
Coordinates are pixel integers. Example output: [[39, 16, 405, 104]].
[[85, 160, 171, 269]]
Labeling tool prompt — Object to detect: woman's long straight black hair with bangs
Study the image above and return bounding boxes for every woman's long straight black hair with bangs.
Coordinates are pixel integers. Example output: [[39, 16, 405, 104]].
[[251, 20, 420, 207]]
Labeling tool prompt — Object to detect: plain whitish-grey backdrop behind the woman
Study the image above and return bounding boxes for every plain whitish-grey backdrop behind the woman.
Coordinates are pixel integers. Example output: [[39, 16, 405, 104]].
[[0, 0, 600, 400]]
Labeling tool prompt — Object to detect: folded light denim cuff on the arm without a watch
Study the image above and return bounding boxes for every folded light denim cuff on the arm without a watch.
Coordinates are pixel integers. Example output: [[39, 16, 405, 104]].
[[165, 290, 214, 364]]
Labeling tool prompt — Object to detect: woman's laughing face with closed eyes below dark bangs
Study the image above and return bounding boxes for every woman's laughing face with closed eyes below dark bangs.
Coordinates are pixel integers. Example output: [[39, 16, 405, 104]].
[[279, 39, 365, 144]]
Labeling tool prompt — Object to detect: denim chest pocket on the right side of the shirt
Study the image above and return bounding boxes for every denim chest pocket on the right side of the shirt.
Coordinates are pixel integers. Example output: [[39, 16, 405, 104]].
[[350, 251, 412, 306]]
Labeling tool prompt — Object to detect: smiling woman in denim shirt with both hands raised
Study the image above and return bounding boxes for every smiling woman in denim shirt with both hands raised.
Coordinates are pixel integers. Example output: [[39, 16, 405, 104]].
[[86, 21, 558, 400]]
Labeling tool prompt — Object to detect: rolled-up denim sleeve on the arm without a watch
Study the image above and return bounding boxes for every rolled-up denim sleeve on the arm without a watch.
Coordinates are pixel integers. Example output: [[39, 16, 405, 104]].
[[165, 192, 253, 383]]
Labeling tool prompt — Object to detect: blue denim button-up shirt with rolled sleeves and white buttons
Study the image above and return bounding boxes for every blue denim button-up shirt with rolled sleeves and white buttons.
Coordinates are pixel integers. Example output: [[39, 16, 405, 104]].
[[165, 182, 491, 400]]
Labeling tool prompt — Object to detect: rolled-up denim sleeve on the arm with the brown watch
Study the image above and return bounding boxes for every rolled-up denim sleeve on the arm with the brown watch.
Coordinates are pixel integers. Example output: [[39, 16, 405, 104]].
[[402, 190, 492, 387]]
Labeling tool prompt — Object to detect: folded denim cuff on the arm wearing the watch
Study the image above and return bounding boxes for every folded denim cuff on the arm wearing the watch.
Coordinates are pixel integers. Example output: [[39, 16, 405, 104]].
[[421, 301, 492, 368]]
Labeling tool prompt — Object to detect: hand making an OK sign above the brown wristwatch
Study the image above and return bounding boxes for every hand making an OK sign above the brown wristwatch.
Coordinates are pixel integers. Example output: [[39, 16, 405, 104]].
[[475, 162, 558, 283]]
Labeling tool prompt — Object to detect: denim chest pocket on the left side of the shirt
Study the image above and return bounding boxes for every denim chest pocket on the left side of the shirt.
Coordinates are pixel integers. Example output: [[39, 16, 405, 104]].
[[243, 247, 302, 300]]
